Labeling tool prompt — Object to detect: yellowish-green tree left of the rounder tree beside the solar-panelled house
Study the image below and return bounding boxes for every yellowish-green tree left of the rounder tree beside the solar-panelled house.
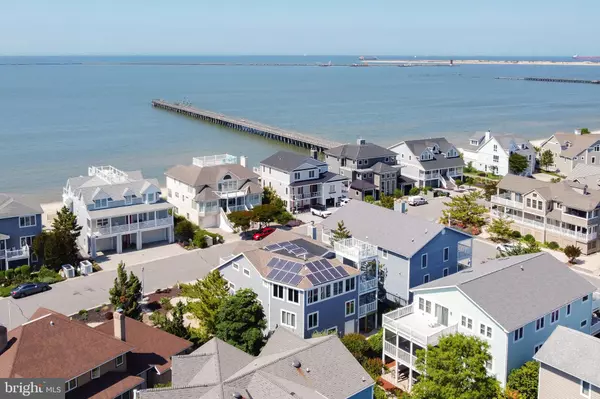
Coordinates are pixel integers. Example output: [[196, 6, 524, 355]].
[[181, 269, 229, 337]]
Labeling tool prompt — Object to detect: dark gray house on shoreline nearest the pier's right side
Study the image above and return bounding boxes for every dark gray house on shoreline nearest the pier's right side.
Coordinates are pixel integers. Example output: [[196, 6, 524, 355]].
[[325, 139, 412, 200]]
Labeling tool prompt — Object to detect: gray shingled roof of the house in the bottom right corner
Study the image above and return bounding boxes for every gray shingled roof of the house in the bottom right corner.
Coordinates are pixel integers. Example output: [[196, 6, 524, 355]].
[[533, 326, 600, 387]]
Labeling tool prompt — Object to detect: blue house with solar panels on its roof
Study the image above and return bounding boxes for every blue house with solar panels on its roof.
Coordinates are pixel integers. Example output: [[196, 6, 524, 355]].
[[218, 231, 378, 338]]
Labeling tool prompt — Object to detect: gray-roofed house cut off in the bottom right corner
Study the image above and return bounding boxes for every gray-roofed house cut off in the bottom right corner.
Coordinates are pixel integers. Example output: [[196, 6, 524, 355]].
[[534, 326, 600, 399]]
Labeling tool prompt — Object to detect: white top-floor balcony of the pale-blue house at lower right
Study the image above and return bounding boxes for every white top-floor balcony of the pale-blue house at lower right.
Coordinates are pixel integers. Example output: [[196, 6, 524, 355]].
[[383, 305, 458, 348]]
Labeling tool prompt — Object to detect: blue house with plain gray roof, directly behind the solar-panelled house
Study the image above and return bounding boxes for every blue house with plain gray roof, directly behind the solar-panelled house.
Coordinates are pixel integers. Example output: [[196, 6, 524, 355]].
[[321, 201, 472, 305]]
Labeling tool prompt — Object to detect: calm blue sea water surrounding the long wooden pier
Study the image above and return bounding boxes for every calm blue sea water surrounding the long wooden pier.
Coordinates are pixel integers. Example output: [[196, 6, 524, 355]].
[[0, 56, 600, 201]]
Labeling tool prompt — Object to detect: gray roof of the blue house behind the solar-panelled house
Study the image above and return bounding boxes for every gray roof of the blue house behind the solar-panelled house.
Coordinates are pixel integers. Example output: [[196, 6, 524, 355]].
[[321, 201, 470, 257]]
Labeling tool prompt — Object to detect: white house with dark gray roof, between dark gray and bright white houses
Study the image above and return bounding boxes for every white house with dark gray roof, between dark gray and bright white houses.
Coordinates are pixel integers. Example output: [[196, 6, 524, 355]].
[[389, 137, 465, 189]]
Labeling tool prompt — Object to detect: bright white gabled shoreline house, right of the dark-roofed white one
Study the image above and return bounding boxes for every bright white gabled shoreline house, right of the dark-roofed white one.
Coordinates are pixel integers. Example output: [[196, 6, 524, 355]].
[[459, 130, 535, 176]]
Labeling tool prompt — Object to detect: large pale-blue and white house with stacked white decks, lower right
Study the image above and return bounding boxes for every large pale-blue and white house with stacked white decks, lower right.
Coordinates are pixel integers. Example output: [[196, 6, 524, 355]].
[[383, 252, 600, 389]]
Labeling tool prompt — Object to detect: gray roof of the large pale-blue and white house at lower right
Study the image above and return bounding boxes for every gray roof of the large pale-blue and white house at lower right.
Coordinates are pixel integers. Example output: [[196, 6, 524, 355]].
[[412, 252, 596, 332]]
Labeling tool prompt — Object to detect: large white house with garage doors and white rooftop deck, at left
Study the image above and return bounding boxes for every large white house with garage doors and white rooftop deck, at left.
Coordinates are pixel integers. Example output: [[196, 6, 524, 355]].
[[63, 166, 174, 257]]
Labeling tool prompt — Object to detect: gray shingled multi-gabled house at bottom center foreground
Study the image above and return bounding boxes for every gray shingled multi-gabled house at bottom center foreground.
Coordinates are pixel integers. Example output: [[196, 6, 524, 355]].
[[136, 328, 374, 399]]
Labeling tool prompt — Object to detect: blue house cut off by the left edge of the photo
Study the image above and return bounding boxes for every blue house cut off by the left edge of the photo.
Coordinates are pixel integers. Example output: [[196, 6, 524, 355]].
[[0, 194, 42, 270]]
